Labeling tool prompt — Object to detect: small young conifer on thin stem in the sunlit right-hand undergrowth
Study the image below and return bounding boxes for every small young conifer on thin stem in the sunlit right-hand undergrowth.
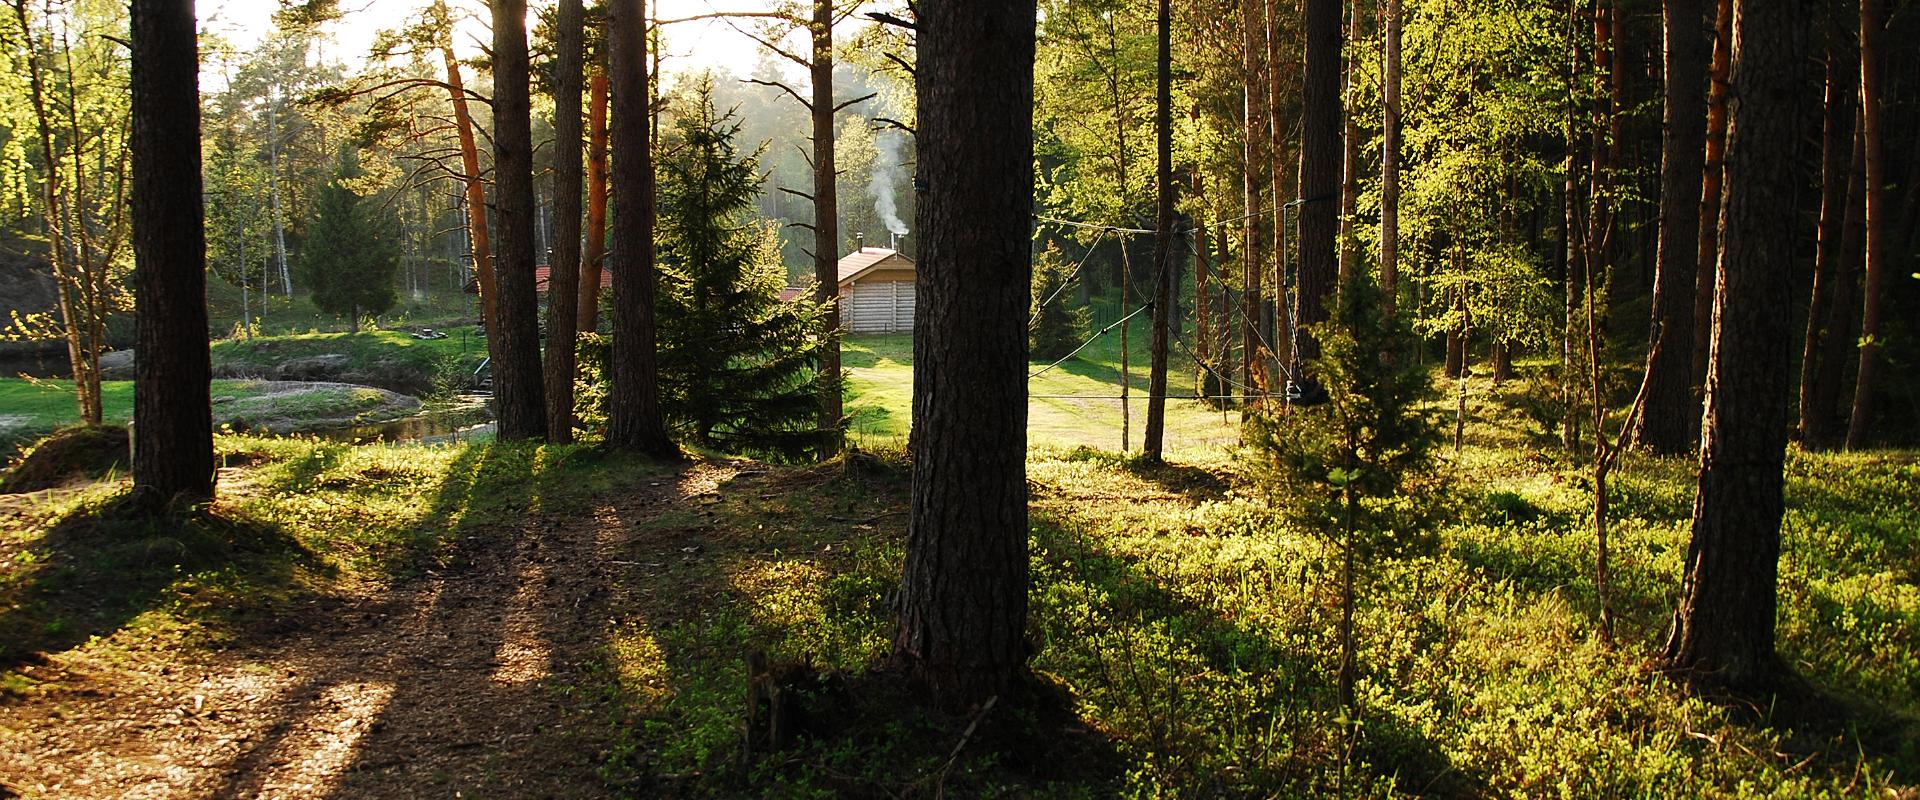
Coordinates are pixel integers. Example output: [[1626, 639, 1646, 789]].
[[1246, 271, 1442, 706]]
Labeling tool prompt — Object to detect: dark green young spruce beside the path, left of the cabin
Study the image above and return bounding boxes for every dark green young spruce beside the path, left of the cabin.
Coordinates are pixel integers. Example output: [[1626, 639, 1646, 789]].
[[657, 79, 828, 459]]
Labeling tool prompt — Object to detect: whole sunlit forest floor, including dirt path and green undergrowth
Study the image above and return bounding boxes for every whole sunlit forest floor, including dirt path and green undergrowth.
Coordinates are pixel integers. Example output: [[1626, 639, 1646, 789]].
[[0, 366, 1920, 798]]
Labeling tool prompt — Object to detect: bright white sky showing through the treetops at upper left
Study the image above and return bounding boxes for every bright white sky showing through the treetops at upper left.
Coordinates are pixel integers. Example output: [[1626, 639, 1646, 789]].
[[200, 0, 794, 84]]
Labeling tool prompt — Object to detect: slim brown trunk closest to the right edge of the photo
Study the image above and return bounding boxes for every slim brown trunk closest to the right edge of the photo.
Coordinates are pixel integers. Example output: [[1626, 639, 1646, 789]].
[[1847, 0, 1893, 451]]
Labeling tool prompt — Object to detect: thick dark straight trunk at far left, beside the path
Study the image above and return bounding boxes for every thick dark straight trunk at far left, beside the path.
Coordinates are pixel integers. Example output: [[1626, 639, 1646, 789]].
[[131, 0, 213, 510]]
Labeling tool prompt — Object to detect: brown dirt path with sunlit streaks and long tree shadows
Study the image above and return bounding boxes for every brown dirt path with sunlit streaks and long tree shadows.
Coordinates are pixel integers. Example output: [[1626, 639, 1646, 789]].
[[0, 464, 733, 798]]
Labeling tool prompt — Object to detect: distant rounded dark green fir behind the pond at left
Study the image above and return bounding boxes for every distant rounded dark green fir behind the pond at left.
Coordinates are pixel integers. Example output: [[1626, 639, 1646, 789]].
[[300, 152, 399, 332]]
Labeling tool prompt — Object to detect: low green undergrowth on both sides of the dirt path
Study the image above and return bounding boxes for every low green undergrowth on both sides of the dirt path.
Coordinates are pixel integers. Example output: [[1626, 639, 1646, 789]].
[[0, 395, 1920, 798]]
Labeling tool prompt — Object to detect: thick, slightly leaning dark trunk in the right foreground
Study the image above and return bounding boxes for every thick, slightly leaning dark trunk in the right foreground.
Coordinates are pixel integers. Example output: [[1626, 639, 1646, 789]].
[[1665, 0, 1812, 691]]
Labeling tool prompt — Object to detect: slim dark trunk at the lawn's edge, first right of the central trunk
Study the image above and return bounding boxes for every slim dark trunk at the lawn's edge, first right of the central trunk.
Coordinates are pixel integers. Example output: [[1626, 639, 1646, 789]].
[[1140, 0, 1175, 462]]
